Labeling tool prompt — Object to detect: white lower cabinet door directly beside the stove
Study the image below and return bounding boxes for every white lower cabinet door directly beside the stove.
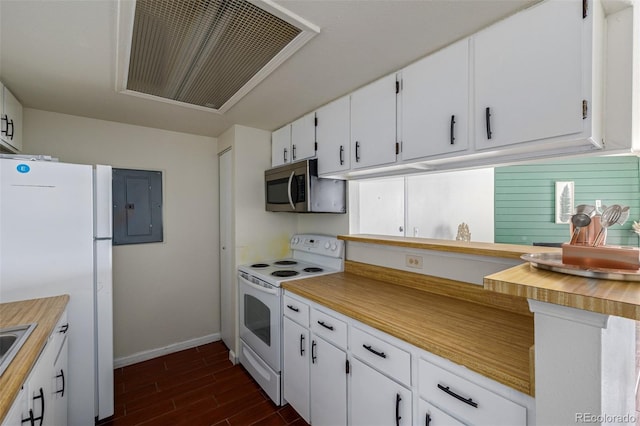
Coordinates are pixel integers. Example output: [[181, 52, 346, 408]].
[[282, 317, 316, 425]]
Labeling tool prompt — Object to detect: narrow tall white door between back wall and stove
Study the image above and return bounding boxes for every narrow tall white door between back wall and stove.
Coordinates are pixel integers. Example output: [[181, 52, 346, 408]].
[[218, 149, 238, 357]]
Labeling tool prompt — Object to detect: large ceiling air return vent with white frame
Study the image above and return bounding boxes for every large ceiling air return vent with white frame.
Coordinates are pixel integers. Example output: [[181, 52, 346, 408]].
[[117, 0, 319, 113]]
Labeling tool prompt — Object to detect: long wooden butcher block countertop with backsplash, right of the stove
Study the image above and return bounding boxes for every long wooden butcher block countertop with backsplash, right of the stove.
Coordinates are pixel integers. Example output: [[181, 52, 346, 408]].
[[283, 261, 534, 395]]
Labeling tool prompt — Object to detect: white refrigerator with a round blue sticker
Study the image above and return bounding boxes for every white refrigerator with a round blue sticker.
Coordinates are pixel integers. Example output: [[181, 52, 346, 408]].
[[0, 155, 113, 426]]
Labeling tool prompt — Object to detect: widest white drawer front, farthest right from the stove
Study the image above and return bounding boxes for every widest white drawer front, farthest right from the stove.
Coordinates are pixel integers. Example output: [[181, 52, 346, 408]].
[[418, 359, 527, 426]]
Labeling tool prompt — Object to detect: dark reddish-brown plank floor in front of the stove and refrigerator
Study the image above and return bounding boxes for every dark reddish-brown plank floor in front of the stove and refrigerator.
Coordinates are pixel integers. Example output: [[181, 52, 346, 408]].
[[98, 342, 307, 426]]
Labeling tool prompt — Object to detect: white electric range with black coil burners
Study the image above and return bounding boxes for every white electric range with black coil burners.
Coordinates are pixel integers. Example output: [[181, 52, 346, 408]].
[[238, 234, 344, 405]]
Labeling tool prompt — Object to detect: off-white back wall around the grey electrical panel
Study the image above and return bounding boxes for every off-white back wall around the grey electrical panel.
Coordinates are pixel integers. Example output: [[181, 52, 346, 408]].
[[23, 108, 220, 362]]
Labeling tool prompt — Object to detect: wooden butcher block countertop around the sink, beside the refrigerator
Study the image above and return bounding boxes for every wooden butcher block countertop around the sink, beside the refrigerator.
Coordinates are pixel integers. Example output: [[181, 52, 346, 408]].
[[0, 295, 69, 422]]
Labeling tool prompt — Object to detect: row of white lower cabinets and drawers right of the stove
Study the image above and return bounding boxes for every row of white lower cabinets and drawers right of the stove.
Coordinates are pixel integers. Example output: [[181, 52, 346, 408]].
[[282, 292, 535, 426]]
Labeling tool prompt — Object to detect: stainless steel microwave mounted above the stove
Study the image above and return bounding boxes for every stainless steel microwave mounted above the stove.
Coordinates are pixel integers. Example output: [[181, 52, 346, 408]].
[[264, 159, 347, 213]]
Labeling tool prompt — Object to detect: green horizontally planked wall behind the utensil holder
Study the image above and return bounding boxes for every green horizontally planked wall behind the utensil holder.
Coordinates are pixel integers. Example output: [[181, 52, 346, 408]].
[[494, 156, 640, 247]]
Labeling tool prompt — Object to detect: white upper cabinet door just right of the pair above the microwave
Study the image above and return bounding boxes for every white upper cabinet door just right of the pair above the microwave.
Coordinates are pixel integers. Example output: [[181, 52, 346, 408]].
[[316, 96, 351, 176]]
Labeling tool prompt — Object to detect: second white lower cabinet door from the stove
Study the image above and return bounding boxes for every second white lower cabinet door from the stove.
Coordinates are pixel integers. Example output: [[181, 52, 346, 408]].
[[311, 336, 347, 426]]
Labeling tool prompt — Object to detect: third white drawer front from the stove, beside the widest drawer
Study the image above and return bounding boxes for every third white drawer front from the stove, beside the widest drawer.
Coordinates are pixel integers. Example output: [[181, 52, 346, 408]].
[[350, 327, 411, 386]]
